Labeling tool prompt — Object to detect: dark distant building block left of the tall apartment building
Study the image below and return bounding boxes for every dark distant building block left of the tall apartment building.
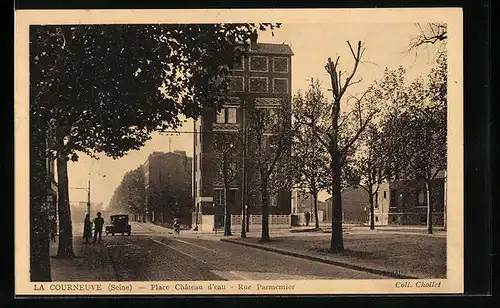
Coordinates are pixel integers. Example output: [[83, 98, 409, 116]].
[[141, 151, 193, 225]]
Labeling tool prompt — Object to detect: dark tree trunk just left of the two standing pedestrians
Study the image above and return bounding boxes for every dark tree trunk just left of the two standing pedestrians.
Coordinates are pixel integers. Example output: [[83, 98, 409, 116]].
[[57, 154, 74, 258]]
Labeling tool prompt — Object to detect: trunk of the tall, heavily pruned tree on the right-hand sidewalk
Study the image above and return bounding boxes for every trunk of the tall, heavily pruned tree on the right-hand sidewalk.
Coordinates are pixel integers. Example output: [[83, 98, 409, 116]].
[[330, 160, 344, 252]]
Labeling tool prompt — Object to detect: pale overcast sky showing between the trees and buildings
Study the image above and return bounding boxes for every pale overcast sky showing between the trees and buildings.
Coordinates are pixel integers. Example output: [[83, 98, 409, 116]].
[[68, 22, 442, 206]]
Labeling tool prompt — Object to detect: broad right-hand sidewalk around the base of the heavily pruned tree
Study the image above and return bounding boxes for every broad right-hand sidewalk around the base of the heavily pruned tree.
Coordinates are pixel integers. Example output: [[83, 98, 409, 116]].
[[221, 231, 446, 279]]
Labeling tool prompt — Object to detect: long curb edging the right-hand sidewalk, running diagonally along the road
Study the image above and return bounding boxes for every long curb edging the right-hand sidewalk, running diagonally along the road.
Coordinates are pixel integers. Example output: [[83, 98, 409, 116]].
[[220, 239, 421, 279]]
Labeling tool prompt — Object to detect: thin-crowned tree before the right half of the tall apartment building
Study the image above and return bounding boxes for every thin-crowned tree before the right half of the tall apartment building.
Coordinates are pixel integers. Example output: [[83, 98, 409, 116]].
[[249, 104, 292, 241]]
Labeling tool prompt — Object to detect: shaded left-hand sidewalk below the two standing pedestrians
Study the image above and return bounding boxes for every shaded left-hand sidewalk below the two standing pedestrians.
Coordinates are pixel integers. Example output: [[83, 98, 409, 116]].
[[50, 232, 116, 281]]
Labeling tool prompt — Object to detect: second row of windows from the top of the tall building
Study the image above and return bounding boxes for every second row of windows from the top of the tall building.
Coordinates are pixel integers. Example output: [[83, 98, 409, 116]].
[[229, 76, 288, 94]]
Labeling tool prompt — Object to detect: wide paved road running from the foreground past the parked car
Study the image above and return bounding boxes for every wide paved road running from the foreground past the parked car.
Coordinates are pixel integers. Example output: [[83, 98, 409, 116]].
[[80, 224, 382, 281]]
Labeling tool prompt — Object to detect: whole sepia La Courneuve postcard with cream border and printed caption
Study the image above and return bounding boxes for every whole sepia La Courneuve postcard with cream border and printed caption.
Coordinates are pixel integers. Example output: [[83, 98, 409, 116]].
[[15, 8, 464, 296]]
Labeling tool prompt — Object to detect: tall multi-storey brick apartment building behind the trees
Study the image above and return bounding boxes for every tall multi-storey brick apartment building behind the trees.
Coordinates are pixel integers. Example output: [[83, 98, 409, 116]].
[[193, 39, 293, 230]]
